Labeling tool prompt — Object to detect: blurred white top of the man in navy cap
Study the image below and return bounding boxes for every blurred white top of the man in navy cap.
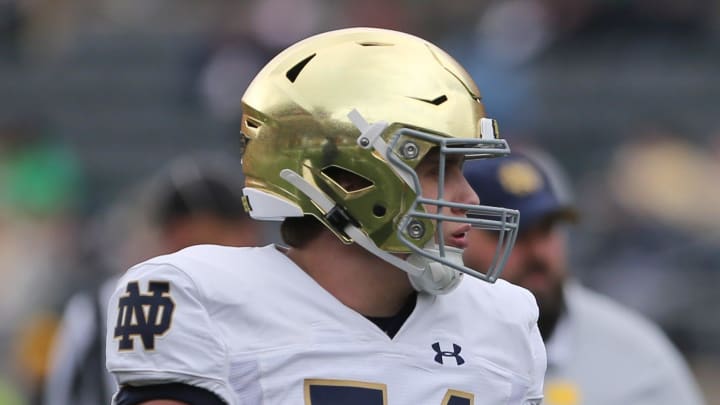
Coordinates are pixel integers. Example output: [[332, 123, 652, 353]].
[[545, 283, 704, 405]]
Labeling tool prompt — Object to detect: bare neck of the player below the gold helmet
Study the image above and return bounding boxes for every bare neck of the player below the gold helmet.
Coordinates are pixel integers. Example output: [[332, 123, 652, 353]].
[[288, 232, 413, 317]]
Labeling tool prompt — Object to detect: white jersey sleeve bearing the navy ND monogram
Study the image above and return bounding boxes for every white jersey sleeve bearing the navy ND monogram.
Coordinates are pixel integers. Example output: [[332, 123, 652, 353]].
[[106, 262, 237, 405]]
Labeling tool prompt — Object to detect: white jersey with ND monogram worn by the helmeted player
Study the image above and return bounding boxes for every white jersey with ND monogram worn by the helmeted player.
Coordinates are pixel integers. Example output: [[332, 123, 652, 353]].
[[107, 245, 545, 405]]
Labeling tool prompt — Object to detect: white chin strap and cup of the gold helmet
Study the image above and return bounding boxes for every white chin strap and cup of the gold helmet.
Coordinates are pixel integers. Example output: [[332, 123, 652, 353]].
[[280, 169, 463, 295]]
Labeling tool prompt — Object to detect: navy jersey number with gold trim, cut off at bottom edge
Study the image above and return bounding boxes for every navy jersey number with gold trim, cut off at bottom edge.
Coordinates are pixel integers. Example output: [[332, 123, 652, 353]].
[[305, 379, 475, 405]]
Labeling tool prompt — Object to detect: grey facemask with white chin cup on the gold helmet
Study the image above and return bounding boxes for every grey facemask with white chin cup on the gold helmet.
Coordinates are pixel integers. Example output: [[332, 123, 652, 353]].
[[349, 110, 519, 294]]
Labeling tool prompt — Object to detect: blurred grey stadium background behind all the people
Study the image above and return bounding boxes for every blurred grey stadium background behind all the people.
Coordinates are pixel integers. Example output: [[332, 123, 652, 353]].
[[0, 0, 720, 405]]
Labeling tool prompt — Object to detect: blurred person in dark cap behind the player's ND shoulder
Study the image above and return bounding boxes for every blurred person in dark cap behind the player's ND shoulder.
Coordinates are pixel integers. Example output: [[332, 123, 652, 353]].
[[43, 154, 264, 405]]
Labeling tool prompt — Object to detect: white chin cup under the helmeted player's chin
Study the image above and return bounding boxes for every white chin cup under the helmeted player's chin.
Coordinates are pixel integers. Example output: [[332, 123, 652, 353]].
[[406, 245, 463, 295]]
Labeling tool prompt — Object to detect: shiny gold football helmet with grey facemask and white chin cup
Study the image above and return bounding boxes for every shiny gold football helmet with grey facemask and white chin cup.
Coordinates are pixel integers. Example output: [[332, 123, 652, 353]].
[[242, 28, 519, 294]]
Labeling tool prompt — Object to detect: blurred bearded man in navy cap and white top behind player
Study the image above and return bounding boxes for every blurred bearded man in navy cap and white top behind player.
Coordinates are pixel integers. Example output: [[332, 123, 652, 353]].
[[464, 149, 703, 405]]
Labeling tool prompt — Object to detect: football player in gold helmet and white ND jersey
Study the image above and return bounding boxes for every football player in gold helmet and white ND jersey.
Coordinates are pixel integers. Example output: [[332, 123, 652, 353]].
[[107, 28, 545, 405]]
